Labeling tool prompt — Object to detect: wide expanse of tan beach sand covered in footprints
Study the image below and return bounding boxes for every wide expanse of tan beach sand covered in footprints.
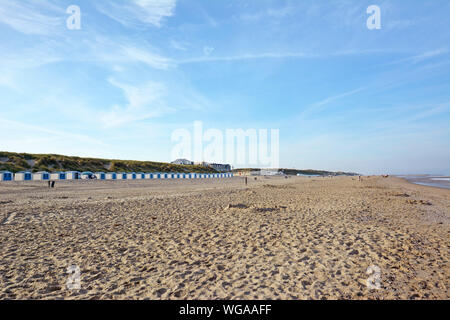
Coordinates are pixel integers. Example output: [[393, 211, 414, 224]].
[[0, 177, 450, 299]]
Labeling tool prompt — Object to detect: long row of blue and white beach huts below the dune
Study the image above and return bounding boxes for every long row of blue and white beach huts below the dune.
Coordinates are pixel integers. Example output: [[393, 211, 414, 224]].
[[0, 171, 233, 181]]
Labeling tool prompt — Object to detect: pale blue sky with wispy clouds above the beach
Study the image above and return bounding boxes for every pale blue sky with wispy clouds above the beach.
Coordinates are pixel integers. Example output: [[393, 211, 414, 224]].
[[0, 0, 450, 174]]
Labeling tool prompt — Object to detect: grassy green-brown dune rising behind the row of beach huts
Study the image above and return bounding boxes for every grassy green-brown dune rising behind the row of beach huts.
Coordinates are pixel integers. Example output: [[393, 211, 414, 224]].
[[0, 151, 217, 173]]
